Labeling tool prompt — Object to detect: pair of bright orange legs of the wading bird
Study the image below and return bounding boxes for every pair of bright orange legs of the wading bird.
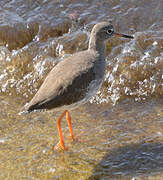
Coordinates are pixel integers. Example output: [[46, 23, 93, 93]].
[[57, 110, 74, 150]]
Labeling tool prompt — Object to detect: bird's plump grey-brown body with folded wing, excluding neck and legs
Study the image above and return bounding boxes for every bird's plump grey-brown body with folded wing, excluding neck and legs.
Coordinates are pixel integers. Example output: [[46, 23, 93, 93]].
[[25, 50, 105, 111]]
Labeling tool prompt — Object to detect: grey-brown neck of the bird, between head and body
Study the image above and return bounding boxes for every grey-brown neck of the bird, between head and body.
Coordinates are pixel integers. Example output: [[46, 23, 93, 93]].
[[88, 36, 105, 57]]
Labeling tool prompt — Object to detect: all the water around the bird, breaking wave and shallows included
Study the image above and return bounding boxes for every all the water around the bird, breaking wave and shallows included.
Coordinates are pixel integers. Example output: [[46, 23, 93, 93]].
[[0, 0, 163, 180]]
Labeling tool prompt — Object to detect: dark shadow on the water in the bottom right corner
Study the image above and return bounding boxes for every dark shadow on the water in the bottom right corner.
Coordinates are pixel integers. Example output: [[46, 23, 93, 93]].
[[89, 143, 163, 180]]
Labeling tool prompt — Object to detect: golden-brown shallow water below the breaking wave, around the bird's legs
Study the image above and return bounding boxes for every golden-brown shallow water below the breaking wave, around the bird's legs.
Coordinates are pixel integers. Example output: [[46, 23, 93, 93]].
[[0, 98, 163, 179]]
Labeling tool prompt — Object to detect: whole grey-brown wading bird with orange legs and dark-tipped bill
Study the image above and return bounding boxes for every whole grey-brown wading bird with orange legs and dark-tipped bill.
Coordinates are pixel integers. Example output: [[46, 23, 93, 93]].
[[25, 22, 133, 150]]
